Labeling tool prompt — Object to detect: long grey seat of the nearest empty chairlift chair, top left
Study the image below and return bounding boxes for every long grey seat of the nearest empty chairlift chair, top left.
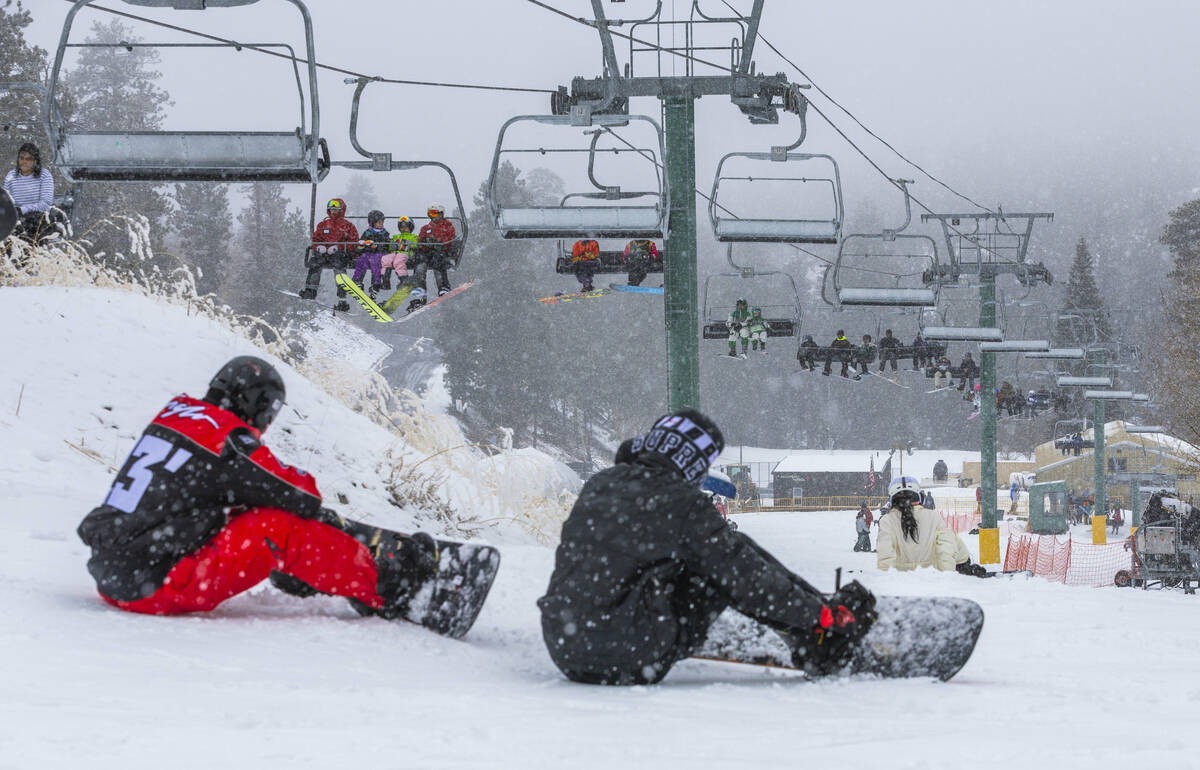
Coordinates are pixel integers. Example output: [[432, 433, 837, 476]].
[[58, 131, 329, 182]]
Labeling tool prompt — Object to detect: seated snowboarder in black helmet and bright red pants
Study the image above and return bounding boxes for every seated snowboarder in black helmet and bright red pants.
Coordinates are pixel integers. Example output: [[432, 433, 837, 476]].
[[78, 356, 437, 619]]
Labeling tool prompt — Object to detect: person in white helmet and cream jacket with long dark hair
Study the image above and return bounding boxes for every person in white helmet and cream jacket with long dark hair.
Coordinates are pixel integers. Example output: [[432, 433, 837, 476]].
[[875, 476, 988, 577]]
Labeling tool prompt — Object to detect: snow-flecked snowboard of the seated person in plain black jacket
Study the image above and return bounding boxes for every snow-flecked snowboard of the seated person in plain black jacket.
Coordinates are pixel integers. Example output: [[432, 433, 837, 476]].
[[695, 596, 983, 681]]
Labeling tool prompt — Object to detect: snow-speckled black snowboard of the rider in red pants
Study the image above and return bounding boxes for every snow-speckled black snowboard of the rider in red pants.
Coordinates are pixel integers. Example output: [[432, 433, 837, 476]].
[[335, 518, 500, 639]]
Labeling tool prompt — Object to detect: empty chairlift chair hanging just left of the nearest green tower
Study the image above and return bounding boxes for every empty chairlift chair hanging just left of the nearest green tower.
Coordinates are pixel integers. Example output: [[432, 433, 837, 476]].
[[487, 112, 671, 240]]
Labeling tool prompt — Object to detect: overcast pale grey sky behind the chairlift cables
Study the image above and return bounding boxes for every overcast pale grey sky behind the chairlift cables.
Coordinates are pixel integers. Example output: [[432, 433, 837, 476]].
[[26, 0, 1200, 268]]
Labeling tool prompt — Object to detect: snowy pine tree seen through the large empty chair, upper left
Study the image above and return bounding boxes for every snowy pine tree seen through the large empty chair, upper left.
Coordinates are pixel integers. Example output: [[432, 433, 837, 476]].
[[67, 19, 170, 253]]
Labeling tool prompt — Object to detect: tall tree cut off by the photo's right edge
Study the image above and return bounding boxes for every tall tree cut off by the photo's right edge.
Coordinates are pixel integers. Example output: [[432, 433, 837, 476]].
[[1151, 200, 1200, 445]]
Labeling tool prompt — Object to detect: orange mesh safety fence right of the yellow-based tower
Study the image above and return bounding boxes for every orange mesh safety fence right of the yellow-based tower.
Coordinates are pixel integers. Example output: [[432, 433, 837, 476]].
[[1004, 533, 1133, 588]]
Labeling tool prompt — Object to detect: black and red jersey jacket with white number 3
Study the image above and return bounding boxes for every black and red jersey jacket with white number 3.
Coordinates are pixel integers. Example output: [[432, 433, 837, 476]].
[[78, 396, 320, 601]]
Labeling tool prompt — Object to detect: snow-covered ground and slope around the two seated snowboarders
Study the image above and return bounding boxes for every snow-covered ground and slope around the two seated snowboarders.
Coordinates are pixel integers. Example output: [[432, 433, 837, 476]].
[[7, 288, 1200, 770]]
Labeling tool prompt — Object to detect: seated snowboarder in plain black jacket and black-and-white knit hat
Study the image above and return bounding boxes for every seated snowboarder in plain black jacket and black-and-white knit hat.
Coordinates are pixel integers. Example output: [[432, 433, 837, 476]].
[[538, 409, 875, 685]]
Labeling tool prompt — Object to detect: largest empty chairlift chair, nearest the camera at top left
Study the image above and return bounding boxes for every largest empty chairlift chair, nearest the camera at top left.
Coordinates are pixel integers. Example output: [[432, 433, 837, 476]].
[[42, 0, 329, 184]]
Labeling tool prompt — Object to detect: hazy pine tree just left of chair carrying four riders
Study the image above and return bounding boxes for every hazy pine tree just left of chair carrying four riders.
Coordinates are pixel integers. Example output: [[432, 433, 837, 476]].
[[220, 182, 310, 313]]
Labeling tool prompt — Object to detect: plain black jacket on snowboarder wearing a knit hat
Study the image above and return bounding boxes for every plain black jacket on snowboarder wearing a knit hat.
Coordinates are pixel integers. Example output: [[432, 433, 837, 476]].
[[538, 461, 824, 680]]
